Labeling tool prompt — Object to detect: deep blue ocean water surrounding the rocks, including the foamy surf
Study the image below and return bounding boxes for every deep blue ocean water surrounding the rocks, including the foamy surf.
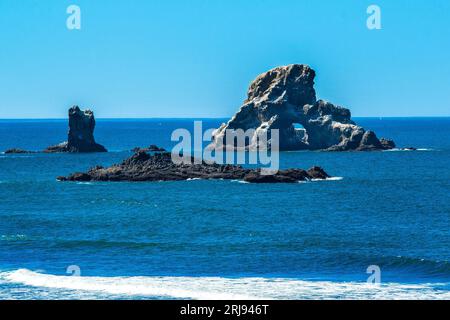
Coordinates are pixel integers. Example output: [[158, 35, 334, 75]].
[[0, 118, 450, 299]]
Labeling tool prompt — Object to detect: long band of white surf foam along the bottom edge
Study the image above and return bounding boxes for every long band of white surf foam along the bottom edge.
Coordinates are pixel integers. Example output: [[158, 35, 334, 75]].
[[0, 269, 450, 300]]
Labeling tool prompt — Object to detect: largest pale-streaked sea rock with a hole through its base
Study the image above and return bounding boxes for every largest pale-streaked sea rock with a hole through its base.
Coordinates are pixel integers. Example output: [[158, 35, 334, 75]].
[[211, 64, 395, 151]]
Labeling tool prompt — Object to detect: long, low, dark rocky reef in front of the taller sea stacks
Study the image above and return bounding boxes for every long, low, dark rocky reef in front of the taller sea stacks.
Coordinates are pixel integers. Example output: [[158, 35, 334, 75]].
[[57, 151, 329, 183]]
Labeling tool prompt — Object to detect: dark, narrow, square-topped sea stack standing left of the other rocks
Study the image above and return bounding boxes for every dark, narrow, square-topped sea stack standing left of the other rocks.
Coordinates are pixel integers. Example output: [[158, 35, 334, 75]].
[[44, 106, 107, 153]]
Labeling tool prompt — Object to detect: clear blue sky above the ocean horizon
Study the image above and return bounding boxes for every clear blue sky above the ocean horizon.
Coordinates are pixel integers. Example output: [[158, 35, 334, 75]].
[[0, 0, 450, 118]]
